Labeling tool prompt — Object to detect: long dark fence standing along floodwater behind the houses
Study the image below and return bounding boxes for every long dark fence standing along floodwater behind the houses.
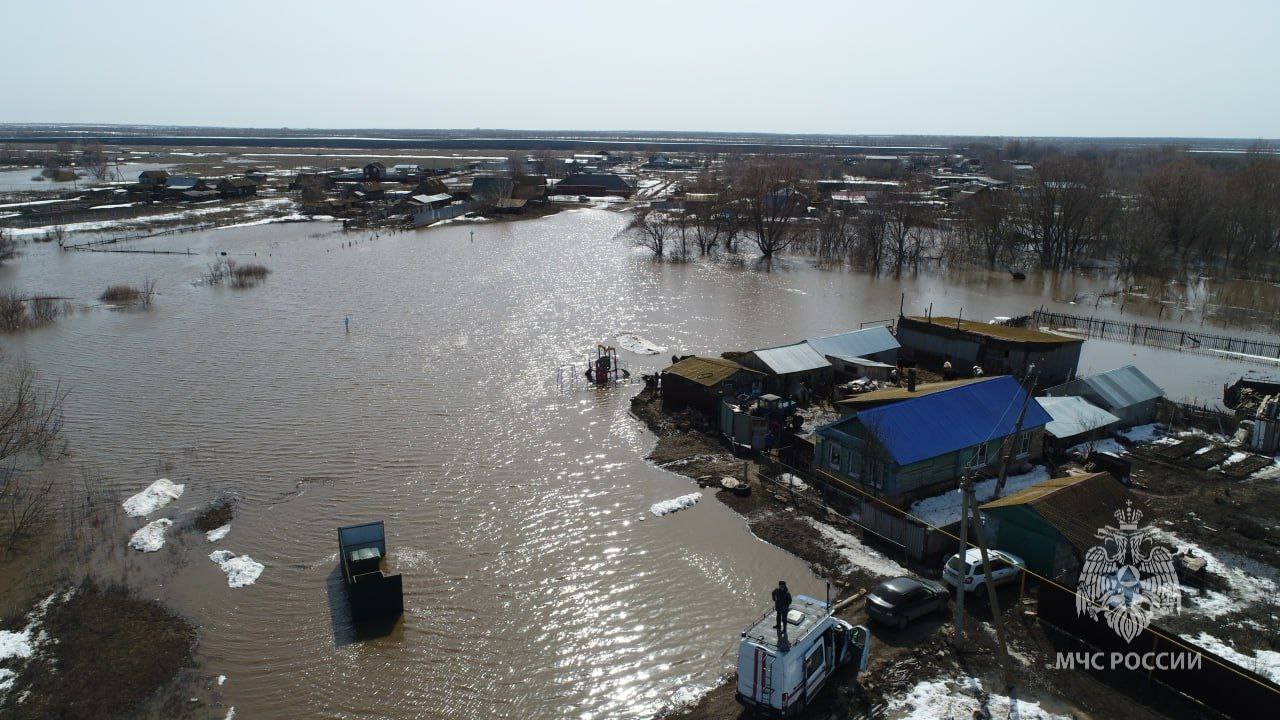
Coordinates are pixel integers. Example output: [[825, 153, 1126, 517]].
[[1032, 310, 1280, 364]]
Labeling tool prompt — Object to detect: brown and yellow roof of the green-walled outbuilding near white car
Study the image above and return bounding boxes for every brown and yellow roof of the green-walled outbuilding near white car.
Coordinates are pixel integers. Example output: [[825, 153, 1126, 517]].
[[979, 473, 1134, 550]]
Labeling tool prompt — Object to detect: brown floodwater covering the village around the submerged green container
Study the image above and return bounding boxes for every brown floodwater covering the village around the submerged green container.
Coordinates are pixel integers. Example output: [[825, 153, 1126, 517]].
[[0, 204, 1259, 717]]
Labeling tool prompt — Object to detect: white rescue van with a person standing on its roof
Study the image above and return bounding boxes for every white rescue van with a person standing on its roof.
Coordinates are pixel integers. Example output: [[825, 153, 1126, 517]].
[[737, 594, 872, 716]]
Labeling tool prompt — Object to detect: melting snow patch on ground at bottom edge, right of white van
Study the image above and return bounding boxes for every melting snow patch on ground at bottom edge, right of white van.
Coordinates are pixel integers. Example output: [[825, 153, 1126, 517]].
[[884, 678, 1070, 720]]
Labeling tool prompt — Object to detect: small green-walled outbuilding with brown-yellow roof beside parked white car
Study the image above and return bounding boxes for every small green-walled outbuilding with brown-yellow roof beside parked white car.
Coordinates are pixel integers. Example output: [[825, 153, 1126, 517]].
[[979, 473, 1138, 578]]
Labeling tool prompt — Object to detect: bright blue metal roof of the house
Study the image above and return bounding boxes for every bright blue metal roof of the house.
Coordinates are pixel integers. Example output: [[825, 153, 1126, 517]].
[[828, 375, 1052, 465]]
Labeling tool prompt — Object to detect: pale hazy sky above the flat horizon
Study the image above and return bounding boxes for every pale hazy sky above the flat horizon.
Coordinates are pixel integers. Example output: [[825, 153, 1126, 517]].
[[0, 0, 1280, 138]]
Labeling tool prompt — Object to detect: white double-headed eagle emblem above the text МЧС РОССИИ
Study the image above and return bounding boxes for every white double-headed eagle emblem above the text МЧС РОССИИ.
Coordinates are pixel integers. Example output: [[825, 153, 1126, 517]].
[[1075, 502, 1181, 642]]
